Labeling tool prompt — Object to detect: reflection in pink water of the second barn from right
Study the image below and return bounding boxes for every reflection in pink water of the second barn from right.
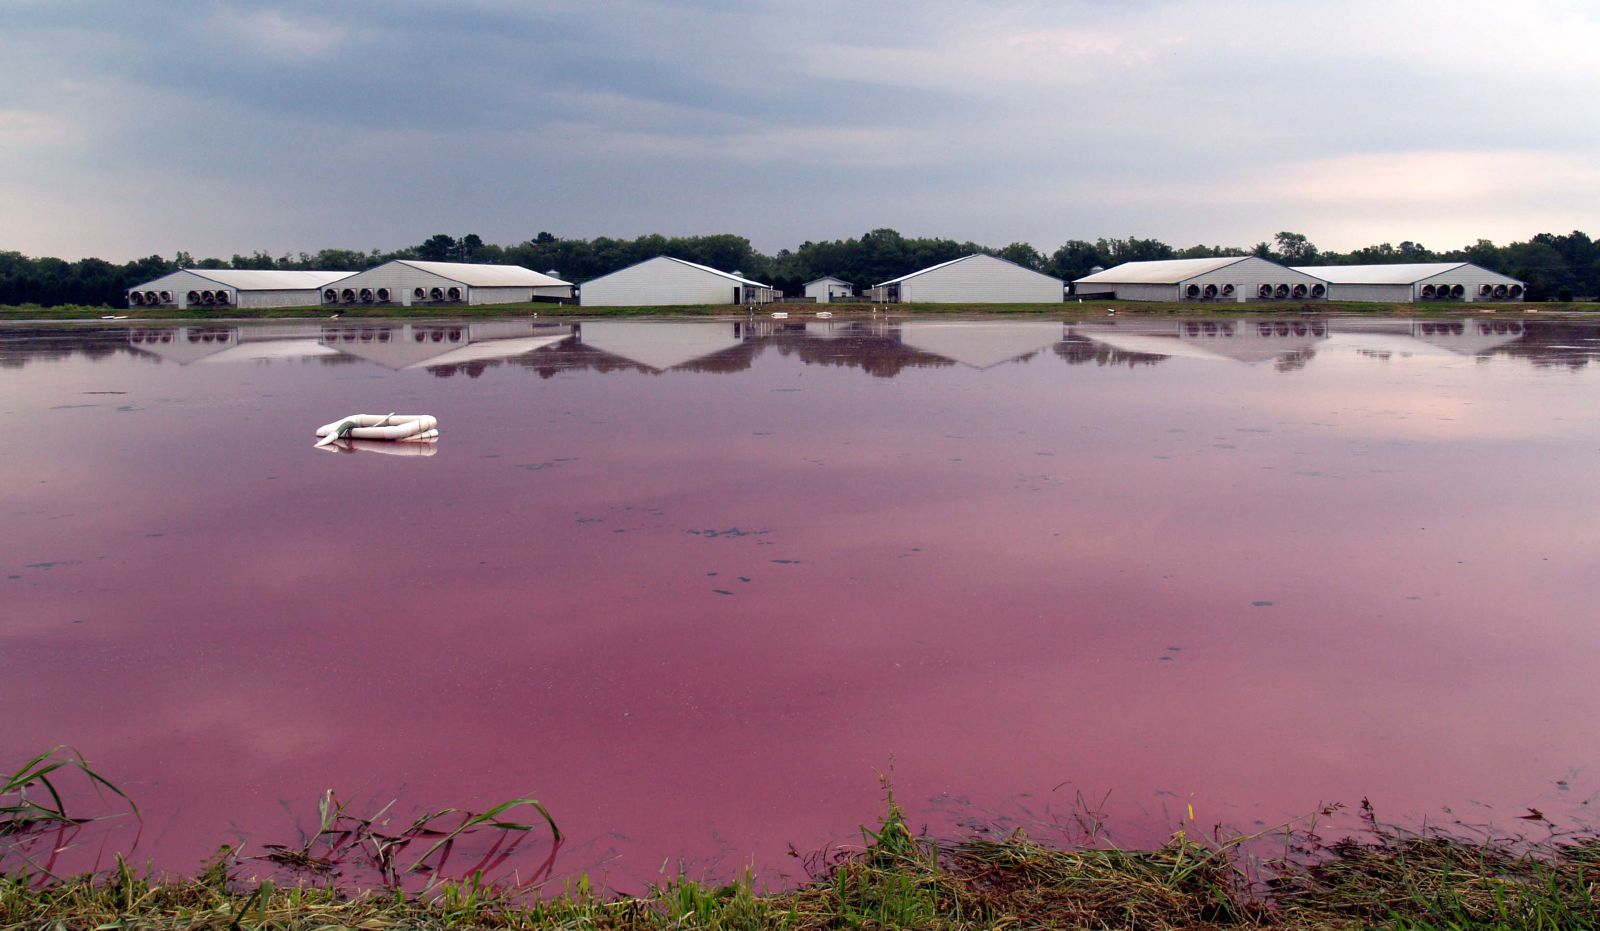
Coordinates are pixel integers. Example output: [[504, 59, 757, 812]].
[[1067, 320, 1328, 365]]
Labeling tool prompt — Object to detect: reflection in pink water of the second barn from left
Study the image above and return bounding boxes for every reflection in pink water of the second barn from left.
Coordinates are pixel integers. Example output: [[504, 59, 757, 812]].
[[318, 320, 573, 371]]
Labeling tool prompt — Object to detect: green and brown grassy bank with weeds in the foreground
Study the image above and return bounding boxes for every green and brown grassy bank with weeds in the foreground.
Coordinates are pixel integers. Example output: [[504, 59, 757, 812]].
[[0, 749, 1600, 931]]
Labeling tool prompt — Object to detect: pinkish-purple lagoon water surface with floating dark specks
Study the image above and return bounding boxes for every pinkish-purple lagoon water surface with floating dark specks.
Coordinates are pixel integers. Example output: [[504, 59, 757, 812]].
[[0, 318, 1600, 888]]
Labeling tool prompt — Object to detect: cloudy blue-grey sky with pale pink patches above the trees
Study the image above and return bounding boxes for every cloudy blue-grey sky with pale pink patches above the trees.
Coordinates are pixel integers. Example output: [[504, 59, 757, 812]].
[[0, 0, 1600, 261]]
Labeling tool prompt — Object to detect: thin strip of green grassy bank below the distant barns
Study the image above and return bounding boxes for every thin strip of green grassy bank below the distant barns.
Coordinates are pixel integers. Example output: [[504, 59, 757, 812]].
[[0, 299, 1600, 323]]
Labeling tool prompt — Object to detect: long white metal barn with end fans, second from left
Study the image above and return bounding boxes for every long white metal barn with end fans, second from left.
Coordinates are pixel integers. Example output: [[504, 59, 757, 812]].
[[322, 259, 573, 307]]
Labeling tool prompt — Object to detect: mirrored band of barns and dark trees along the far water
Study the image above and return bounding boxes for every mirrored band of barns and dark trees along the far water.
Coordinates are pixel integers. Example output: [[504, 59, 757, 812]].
[[0, 317, 1600, 378]]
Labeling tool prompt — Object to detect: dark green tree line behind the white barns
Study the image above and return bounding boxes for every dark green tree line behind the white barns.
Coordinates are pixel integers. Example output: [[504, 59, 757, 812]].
[[0, 229, 1600, 307]]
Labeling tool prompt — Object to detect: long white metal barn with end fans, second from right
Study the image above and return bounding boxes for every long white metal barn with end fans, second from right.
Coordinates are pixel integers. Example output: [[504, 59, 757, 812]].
[[1072, 256, 1328, 301]]
